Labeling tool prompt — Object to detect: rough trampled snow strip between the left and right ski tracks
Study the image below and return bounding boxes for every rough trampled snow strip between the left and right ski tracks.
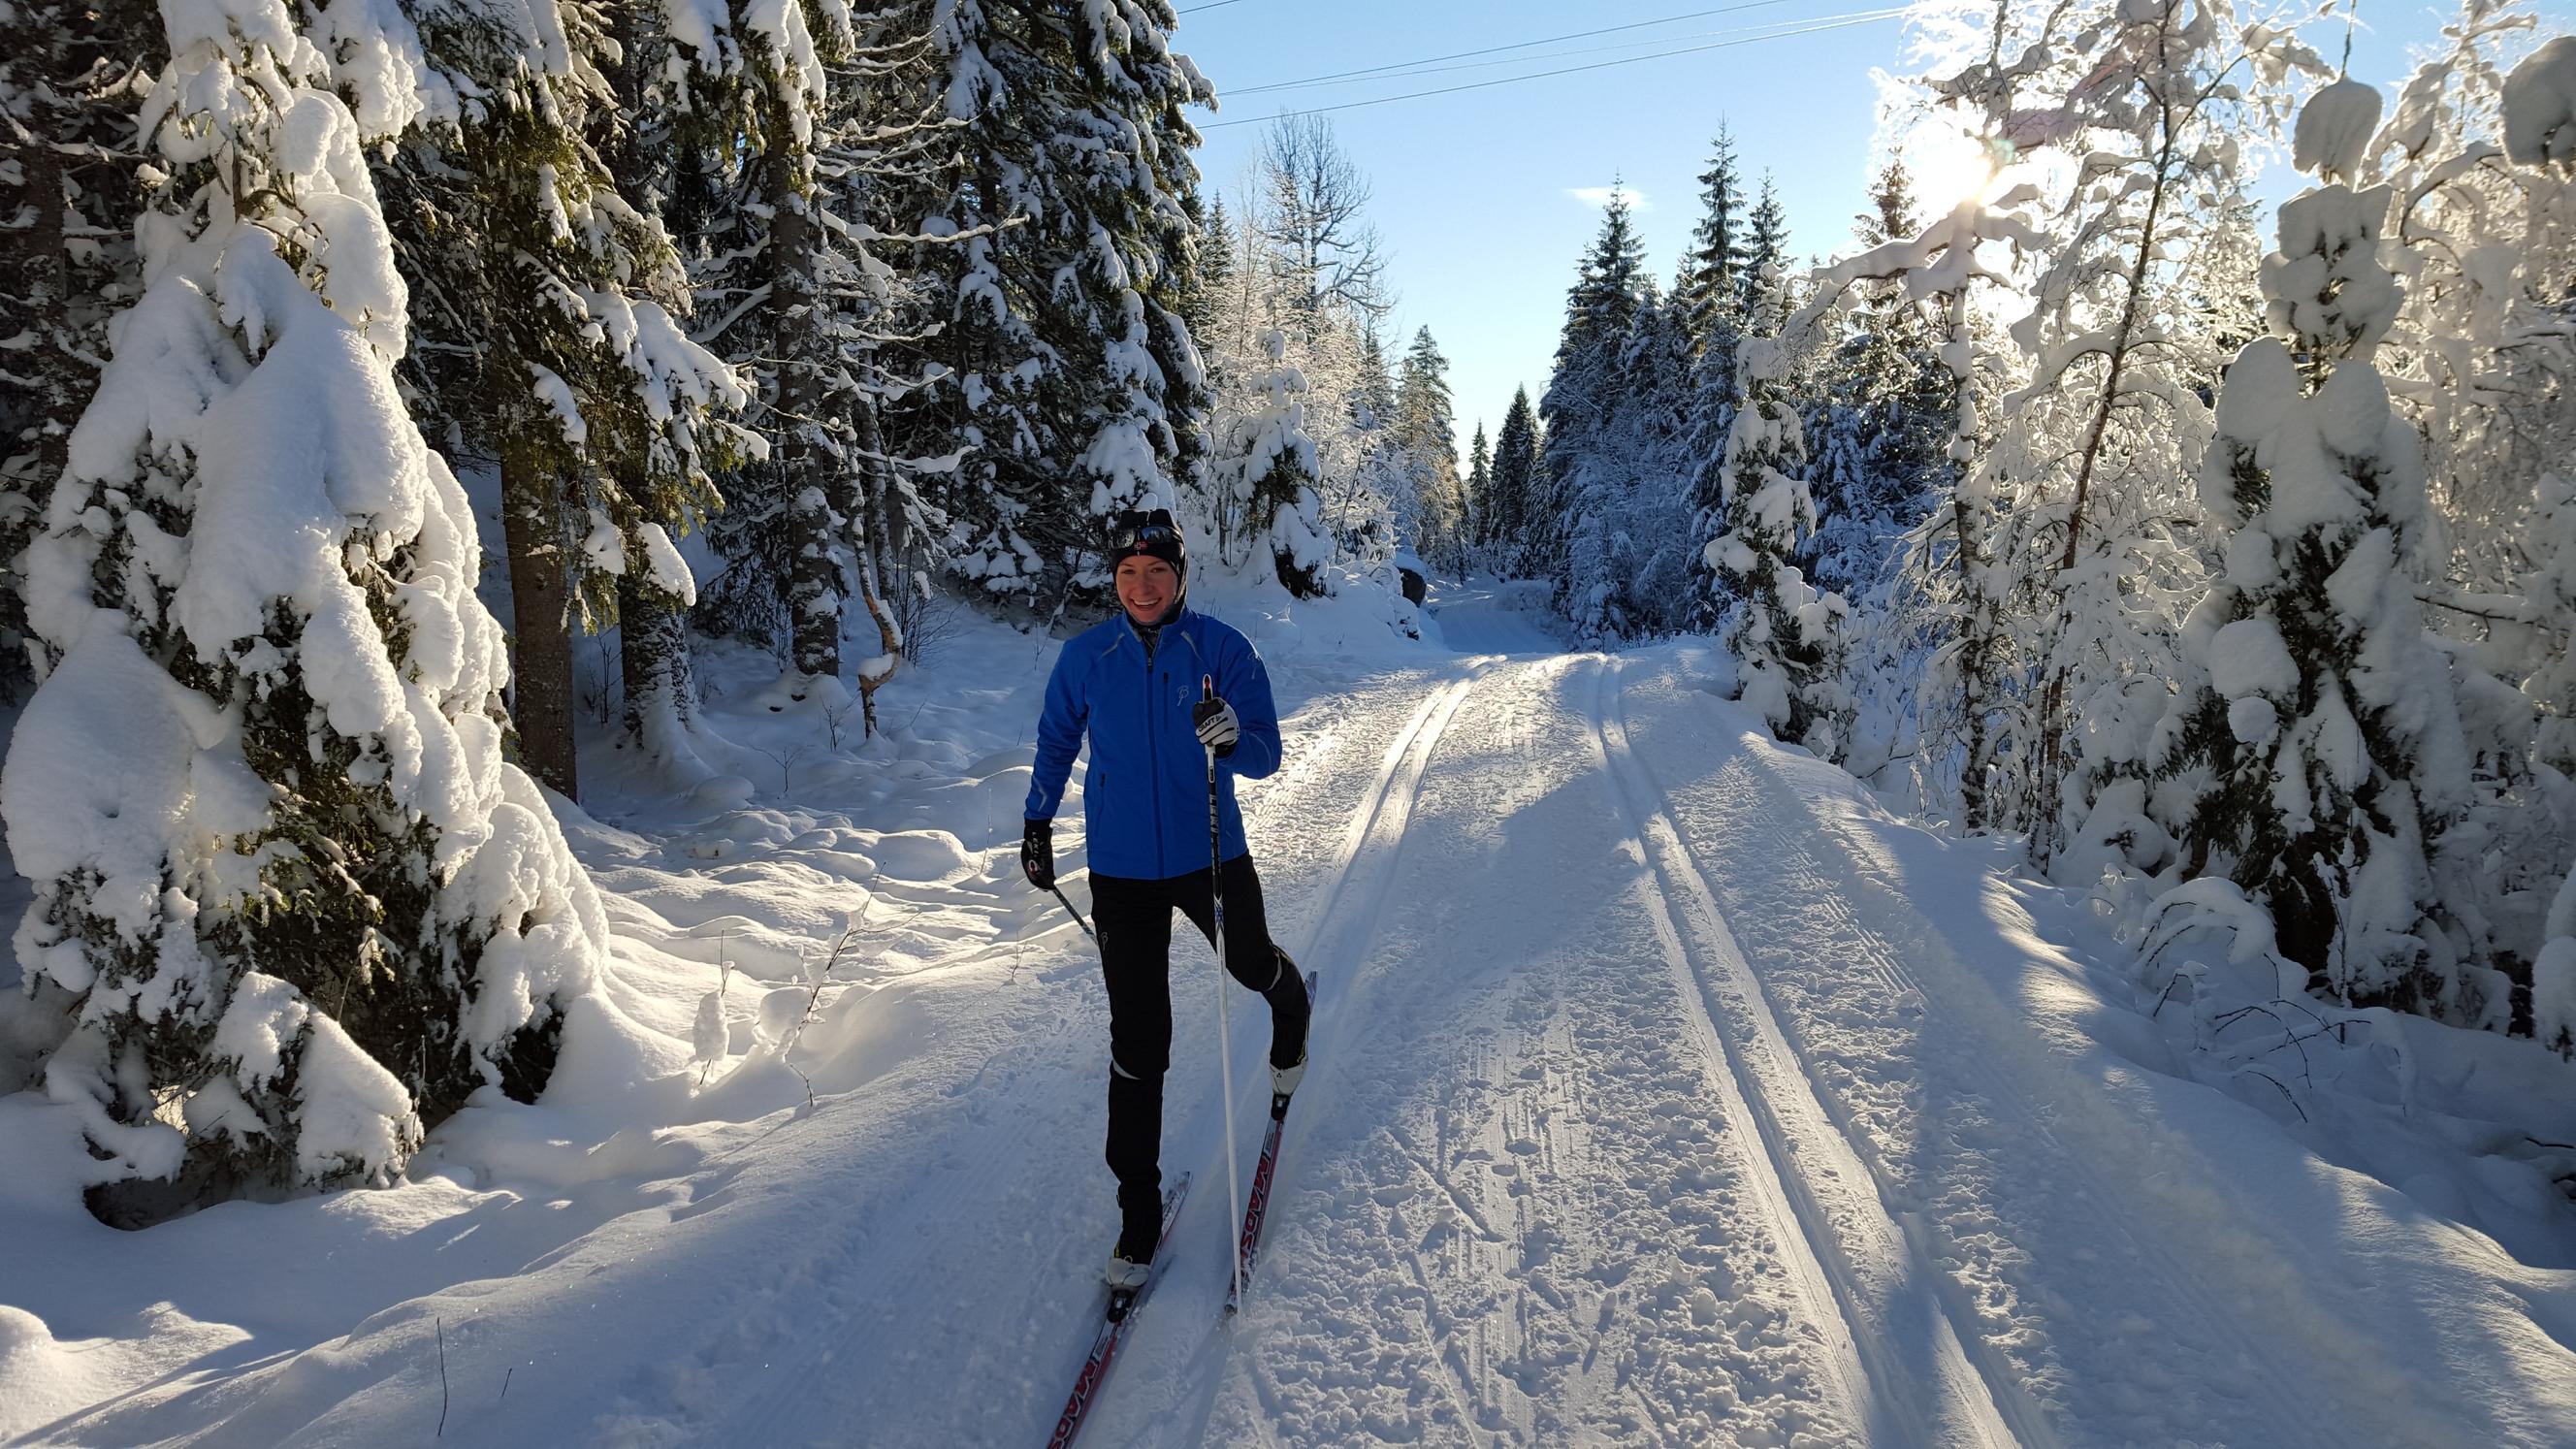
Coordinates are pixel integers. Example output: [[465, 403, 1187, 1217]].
[[1179, 658, 1893, 1444]]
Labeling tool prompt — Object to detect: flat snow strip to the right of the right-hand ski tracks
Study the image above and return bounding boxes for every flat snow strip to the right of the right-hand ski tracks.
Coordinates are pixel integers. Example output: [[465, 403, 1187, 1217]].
[[1605, 678, 2503, 1449]]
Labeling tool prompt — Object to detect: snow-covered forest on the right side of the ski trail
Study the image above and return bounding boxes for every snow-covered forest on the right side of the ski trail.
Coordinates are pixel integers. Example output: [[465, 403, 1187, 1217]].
[[1468, 0, 2576, 1052]]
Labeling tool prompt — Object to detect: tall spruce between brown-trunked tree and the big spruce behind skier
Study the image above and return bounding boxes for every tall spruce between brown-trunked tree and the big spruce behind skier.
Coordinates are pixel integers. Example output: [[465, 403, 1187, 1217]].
[[675, 0, 955, 726]]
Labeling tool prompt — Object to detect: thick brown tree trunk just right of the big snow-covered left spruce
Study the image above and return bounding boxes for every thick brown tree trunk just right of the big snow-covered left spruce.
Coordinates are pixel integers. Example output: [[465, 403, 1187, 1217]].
[[499, 441, 582, 799]]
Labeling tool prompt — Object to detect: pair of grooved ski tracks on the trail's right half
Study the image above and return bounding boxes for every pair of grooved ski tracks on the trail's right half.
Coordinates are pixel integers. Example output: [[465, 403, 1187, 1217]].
[[1592, 658, 2058, 1449]]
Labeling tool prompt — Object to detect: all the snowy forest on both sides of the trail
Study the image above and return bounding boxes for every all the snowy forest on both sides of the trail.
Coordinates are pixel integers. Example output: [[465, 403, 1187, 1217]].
[[0, 0, 2576, 1222]]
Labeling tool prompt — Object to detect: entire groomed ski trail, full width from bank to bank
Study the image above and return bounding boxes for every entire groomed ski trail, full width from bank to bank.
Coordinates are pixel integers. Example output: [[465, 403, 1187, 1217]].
[[674, 621, 2556, 1449]]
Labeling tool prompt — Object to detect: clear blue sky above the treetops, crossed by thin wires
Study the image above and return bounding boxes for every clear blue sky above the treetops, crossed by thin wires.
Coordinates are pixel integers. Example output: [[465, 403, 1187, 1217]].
[[1177, 0, 2450, 449]]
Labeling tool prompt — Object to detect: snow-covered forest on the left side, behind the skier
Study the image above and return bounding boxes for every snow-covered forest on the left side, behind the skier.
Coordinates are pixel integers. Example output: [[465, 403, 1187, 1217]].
[[0, 0, 1461, 1222]]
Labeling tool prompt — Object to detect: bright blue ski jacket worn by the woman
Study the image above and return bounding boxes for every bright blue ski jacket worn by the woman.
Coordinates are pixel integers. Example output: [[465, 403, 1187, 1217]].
[[1022, 608, 1280, 880]]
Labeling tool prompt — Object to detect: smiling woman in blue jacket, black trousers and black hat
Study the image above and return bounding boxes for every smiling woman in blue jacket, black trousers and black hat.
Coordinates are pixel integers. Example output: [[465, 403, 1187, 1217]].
[[1020, 508, 1308, 1292]]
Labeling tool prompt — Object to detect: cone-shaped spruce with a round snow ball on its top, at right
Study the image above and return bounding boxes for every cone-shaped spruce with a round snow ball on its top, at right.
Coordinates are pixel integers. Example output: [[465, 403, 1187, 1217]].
[[2161, 82, 2509, 1026]]
